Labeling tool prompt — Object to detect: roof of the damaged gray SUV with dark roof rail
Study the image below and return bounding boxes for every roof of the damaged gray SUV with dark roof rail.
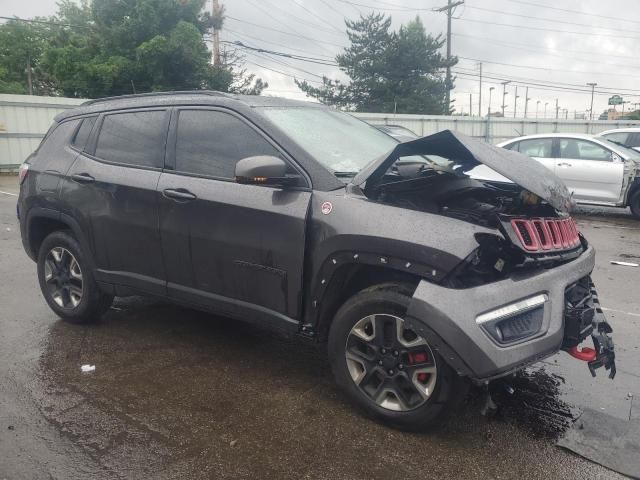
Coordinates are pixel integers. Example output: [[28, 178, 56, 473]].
[[56, 90, 326, 121]]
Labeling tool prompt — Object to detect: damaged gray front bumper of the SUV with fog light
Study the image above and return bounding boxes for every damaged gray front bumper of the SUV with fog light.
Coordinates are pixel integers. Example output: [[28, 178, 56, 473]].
[[406, 247, 615, 380]]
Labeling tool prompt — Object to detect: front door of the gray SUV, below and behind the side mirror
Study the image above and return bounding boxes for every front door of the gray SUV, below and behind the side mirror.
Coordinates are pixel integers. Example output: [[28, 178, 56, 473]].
[[158, 108, 311, 318]]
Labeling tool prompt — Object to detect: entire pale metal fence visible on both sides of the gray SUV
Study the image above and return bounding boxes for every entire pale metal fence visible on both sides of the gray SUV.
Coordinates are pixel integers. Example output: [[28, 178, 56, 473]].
[[0, 95, 640, 171]]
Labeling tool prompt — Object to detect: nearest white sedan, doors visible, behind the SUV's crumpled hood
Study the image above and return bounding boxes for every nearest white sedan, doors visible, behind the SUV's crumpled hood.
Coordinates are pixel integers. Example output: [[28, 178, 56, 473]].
[[470, 133, 640, 218]]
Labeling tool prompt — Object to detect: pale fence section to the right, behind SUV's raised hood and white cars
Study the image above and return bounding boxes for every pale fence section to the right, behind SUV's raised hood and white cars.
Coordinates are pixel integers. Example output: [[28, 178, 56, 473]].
[[355, 113, 640, 143]]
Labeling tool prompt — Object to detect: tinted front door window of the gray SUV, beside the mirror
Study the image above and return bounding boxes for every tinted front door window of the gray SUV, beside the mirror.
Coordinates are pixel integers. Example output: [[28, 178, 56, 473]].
[[176, 110, 282, 178]]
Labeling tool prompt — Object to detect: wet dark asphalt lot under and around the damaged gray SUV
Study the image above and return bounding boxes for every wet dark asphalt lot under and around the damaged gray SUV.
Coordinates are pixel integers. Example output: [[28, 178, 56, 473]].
[[0, 177, 640, 479]]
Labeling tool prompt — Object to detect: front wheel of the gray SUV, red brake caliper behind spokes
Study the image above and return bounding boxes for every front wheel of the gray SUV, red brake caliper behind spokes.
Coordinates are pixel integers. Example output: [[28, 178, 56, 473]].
[[329, 284, 466, 431]]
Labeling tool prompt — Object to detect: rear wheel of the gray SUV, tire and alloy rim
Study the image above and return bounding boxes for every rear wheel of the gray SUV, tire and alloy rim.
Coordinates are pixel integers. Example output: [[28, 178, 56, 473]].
[[38, 231, 113, 323]]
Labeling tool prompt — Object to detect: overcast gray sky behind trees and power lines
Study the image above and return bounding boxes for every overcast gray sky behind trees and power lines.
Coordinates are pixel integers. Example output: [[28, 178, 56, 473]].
[[0, 0, 640, 118]]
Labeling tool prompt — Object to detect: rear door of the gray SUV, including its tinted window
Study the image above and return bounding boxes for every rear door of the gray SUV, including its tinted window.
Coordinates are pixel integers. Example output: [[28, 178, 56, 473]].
[[62, 109, 169, 295]]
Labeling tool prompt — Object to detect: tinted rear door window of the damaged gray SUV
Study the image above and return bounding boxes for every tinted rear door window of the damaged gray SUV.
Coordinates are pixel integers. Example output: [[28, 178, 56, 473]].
[[95, 110, 166, 168]]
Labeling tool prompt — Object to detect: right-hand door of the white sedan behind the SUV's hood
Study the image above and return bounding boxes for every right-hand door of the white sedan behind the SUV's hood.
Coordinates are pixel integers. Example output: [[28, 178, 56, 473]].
[[556, 138, 624, 203]]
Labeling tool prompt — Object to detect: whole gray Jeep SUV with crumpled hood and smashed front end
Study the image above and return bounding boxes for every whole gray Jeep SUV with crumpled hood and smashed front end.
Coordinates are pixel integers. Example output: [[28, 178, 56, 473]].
[[18, 92, 615, 429]]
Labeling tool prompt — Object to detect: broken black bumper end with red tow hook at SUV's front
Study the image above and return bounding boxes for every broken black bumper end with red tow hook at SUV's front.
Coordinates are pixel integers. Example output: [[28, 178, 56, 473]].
[[562, 277, 616, 378]]
